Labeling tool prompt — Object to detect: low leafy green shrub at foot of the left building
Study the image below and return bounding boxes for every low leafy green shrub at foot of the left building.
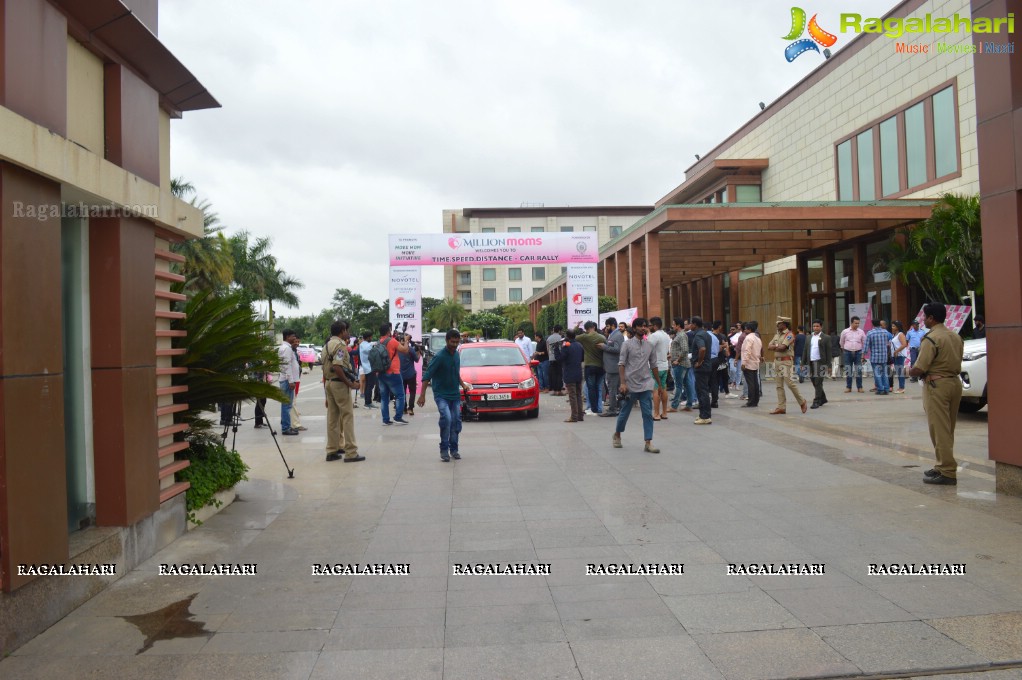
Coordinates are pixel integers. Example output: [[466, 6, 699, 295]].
[[177, 433, 248, 524]]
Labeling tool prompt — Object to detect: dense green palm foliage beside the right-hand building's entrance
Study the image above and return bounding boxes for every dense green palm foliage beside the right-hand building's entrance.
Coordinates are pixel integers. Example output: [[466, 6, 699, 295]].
[[874, 193, 983, 301]]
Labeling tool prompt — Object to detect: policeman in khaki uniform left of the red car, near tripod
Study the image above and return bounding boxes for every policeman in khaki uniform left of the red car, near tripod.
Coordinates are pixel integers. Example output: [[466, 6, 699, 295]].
[[323, 321, 366, 463]]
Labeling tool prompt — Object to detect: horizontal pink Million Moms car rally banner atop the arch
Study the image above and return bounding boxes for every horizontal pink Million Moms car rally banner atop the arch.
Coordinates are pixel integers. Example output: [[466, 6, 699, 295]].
[[390, 231, 600, 265]]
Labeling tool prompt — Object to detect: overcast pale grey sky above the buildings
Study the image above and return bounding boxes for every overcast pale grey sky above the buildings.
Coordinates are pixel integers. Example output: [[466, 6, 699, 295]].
[[159, 0, 896, 315]]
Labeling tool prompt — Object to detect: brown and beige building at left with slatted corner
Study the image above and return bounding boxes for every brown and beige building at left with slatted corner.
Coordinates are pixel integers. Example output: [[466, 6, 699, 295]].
[[0, 0, 219, 653]]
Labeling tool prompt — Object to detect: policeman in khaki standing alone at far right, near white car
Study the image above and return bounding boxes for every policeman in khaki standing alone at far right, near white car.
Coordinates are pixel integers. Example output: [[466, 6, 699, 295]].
[[909, 303, 965, 486]]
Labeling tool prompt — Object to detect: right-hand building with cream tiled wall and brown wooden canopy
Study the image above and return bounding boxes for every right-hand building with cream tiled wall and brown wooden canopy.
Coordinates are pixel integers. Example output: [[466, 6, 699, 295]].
[[528, 0, 1022, 494]]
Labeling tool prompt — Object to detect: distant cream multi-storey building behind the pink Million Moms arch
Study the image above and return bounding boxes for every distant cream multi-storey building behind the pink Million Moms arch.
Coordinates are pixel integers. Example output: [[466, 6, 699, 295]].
[[444, 206, 652, 312]]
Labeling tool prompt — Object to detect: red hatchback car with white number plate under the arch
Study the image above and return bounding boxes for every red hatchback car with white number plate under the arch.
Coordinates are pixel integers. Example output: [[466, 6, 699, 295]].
[[458, 341, 540, 418]]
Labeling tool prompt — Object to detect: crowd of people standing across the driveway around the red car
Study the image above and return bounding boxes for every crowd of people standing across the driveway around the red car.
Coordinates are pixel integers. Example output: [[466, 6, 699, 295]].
[[265, 304, 964, 485]]
